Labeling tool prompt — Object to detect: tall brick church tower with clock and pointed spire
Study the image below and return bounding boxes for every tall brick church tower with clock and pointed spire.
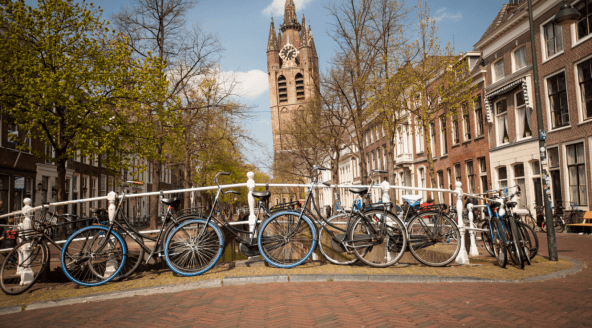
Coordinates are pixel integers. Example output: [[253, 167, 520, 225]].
[[267, 0, 319, 152]]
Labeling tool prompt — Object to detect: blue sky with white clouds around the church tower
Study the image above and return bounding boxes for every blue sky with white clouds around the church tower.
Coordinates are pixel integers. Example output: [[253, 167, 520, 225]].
[[27, 0, 508, 169]]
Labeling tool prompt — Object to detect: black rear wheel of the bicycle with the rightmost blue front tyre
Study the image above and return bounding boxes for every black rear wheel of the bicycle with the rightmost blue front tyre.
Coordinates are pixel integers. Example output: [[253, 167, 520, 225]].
[[350, 210, 407, 268]]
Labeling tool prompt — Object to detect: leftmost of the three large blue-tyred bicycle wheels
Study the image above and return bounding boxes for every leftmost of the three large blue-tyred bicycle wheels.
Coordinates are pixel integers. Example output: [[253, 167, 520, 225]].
[[60, 226, 127, 287]]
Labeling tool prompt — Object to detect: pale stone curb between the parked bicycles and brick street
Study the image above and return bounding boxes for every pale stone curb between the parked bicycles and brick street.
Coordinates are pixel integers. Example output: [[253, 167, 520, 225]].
[[0, 256, 586, 315]]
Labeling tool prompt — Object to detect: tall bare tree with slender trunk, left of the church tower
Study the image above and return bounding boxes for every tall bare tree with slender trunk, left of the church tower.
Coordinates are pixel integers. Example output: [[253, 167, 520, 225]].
[[113, 0, 222, 228]]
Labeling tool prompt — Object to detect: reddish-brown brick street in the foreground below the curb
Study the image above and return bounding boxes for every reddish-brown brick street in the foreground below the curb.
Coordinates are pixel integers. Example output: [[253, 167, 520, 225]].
[[0, 234, 592, 327]]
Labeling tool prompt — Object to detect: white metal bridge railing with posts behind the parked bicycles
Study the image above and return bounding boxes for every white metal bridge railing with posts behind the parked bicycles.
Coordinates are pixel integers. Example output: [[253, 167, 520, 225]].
[[0, 172, 486, 264]]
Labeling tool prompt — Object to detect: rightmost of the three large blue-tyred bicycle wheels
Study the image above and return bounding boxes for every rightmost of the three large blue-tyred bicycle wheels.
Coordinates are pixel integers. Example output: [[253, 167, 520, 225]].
[[257, 212, 317, 268]]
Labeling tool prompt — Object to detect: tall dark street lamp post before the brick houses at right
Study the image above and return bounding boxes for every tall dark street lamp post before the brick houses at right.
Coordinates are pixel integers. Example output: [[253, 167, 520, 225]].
[[528, 0, 580, 261]]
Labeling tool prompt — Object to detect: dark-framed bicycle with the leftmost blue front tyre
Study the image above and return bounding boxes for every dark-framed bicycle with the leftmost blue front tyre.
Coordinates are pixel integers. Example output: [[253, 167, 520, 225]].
[[60, 181, 208, 287]]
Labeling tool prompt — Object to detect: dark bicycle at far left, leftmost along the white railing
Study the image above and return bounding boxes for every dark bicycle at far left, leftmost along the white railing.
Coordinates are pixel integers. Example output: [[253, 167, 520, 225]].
[[0, 203, 93, 295]]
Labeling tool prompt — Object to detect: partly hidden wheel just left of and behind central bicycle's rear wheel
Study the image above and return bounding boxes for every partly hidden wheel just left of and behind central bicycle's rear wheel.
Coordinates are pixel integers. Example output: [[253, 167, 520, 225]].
[[319, 213, 358, 264]]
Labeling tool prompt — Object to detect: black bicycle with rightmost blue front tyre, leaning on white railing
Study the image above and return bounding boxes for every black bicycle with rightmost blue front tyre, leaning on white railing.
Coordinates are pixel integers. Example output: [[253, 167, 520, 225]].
[[258, 165, 406, 268]]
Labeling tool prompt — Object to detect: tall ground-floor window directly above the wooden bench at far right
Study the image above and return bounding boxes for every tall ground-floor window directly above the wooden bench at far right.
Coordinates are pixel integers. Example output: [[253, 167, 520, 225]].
[[567, 142, 588, 205]]
